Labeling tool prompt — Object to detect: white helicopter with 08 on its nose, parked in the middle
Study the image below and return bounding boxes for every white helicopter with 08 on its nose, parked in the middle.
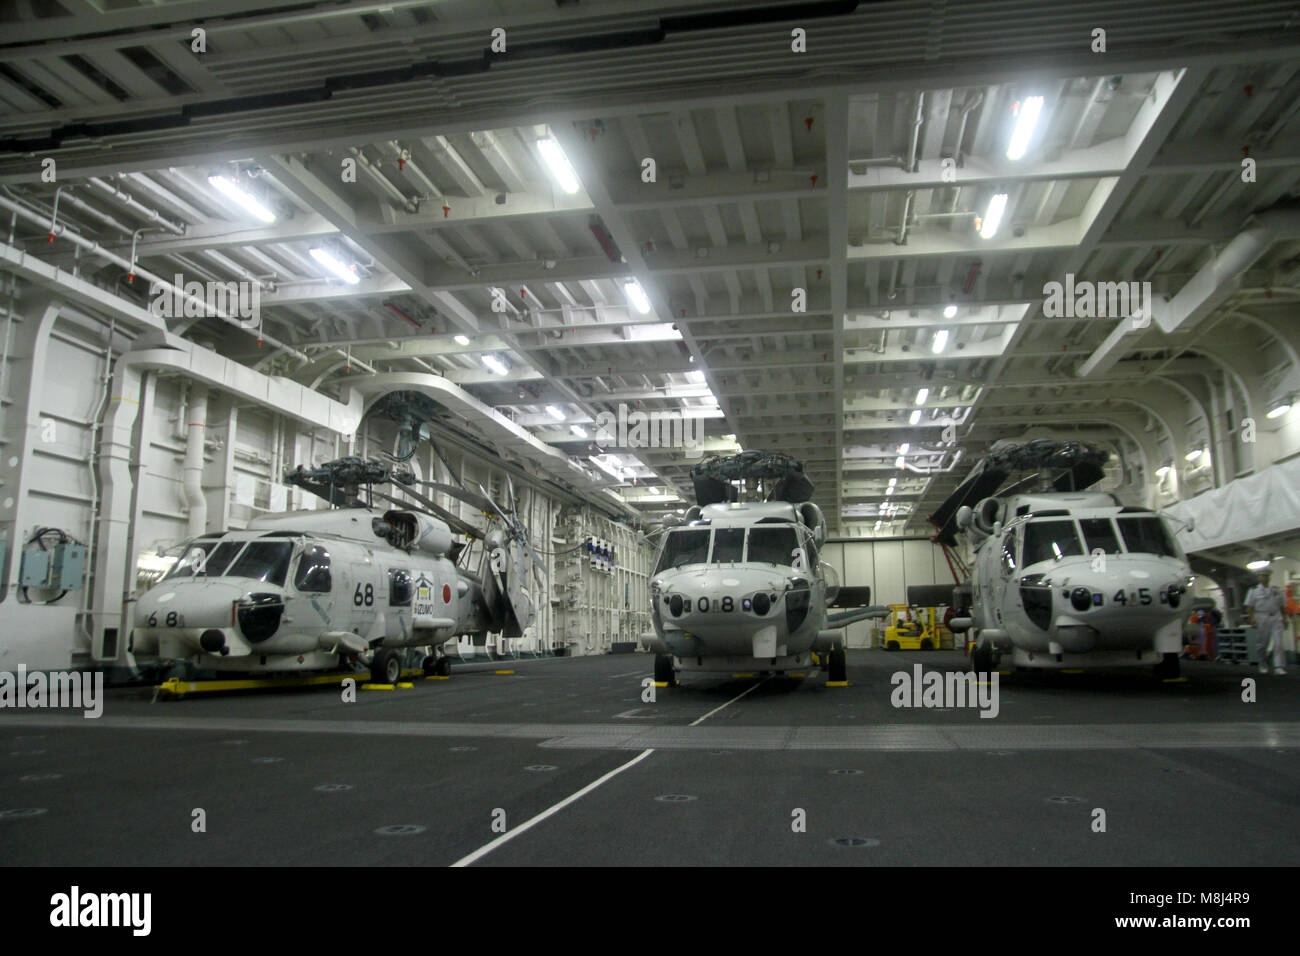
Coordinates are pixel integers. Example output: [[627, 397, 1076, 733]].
[[642, 451, 889, 685]]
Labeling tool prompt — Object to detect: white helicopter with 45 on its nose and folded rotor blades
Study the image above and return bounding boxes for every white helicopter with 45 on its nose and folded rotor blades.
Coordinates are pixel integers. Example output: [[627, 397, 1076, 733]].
[[931, 440, 1195, 678]]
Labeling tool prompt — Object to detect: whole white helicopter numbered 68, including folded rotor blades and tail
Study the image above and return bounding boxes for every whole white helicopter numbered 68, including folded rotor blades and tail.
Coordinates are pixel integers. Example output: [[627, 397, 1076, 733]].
[[133, 458, 541, 684]]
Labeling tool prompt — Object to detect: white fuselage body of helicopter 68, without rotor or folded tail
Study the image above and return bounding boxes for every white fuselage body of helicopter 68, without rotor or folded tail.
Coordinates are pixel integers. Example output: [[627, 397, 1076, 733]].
[[133, 509, 491, 672]]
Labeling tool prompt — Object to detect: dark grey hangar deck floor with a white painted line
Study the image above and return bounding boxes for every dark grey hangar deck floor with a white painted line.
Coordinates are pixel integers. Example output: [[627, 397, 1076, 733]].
[[0, 650, 1300, 866]]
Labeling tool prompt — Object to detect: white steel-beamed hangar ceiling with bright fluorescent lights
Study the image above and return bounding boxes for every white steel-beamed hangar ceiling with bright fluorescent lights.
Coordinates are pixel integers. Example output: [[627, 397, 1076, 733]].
[[0, 0, 1300, 533]]
